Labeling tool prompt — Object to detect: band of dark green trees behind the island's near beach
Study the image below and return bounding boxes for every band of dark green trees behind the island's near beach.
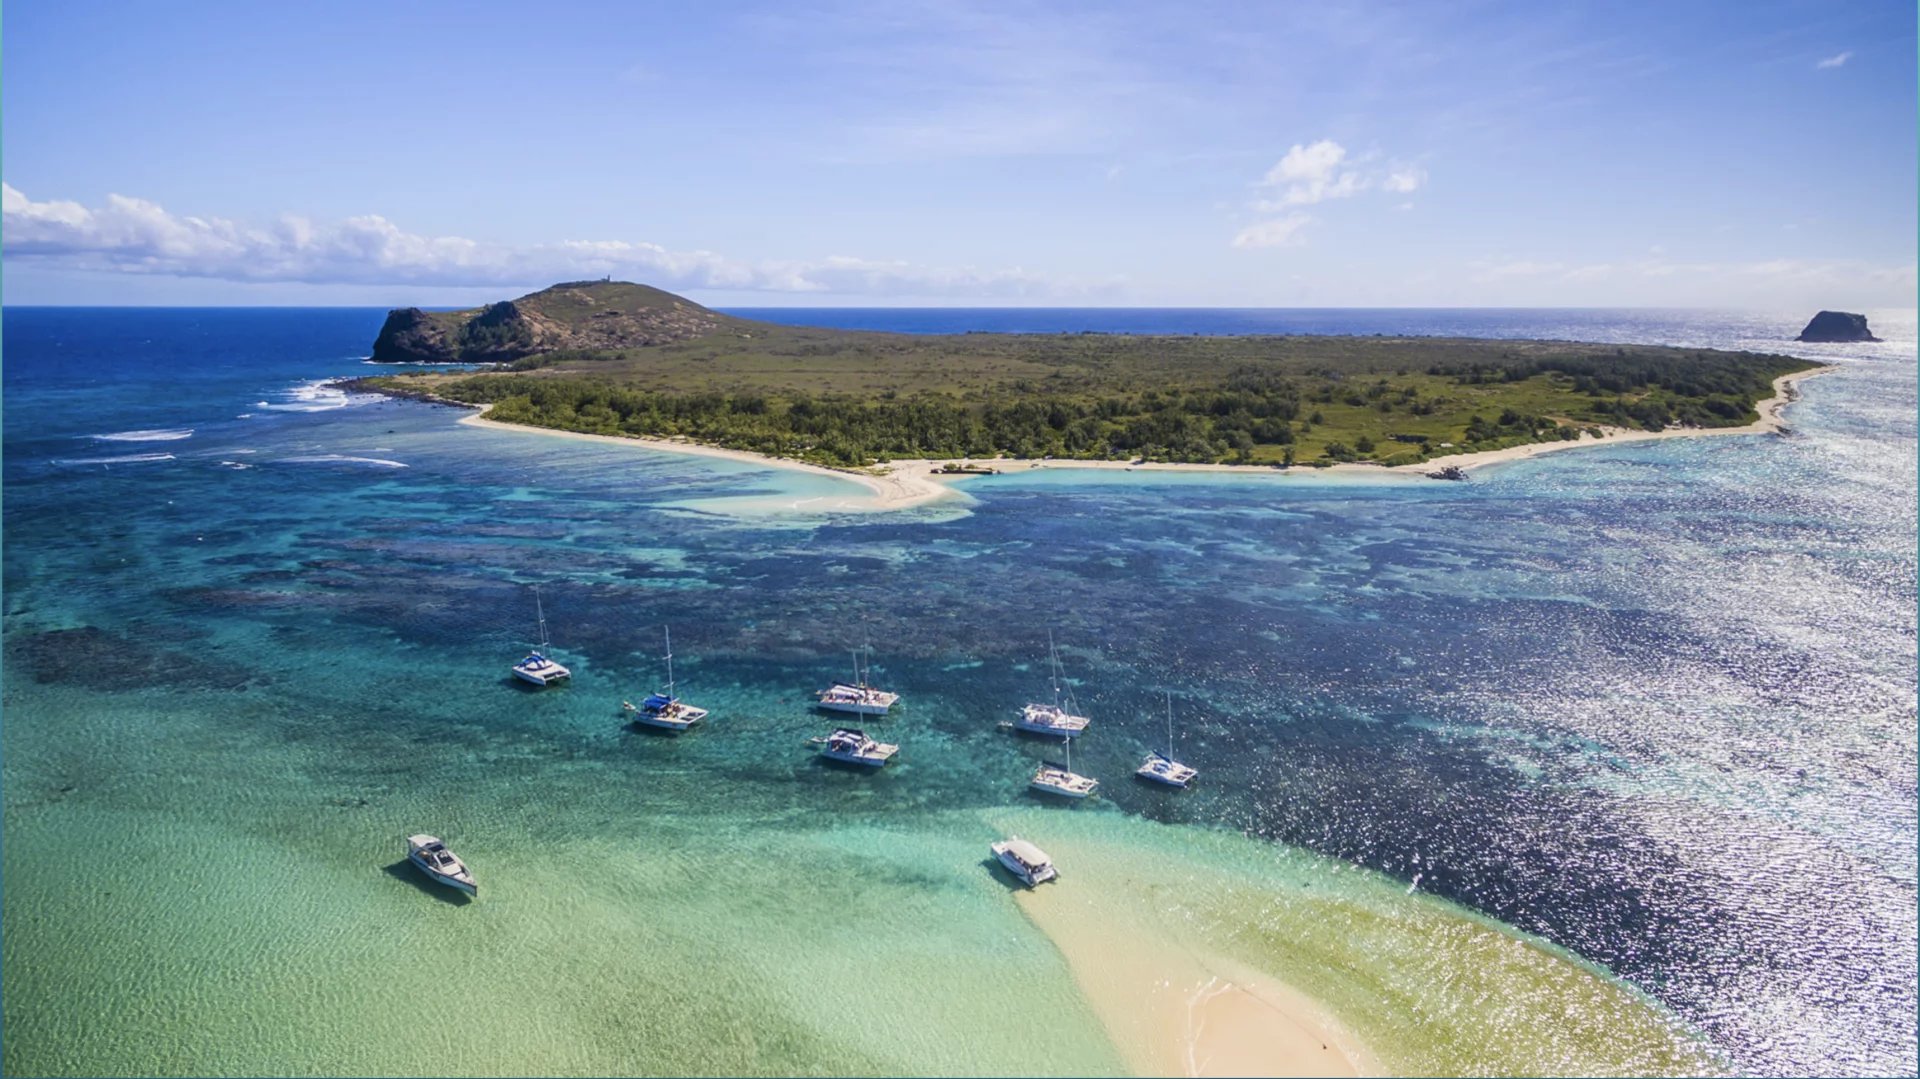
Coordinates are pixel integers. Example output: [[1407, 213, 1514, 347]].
[[397, 343, 1809, 467]]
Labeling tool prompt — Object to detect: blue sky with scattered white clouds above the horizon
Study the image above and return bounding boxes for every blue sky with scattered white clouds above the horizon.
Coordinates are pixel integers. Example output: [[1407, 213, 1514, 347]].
[[0, 0, 1920, 311]]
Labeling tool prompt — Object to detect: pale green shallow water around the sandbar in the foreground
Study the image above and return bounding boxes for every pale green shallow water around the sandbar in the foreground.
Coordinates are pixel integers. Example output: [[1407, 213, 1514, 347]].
[[4, 675, 1709, 1075]]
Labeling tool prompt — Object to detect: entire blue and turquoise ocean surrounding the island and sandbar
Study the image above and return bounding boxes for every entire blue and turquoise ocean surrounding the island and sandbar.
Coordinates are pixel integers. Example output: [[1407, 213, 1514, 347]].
[[0, 307, 1920, 1075]]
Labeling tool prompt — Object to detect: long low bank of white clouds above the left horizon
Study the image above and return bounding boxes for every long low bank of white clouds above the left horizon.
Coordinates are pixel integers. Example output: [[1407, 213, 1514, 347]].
[[0, 182, 1096, 298]]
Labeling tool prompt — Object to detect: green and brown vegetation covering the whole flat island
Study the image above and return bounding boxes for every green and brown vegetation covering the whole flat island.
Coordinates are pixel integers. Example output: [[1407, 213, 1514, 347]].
[[361, 282, 1816, 467]]
